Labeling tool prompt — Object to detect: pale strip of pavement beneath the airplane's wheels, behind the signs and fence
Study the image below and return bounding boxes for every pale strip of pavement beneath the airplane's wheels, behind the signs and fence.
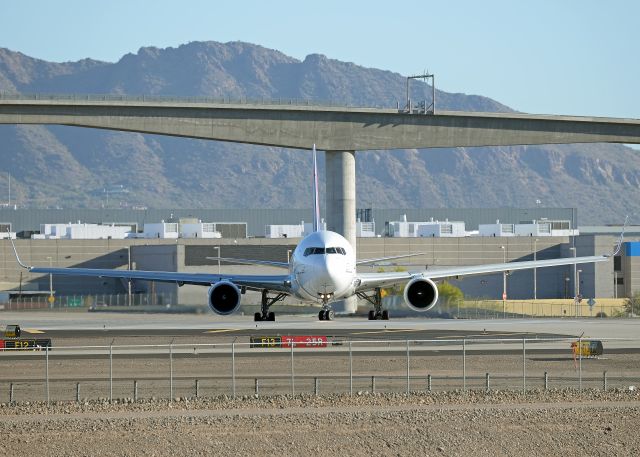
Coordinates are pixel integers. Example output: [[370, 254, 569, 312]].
[[0, 311, 640, 347]]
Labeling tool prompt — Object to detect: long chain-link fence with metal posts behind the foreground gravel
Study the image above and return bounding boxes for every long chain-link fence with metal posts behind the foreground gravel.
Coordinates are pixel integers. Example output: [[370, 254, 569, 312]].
[[0, 338, 640, 402]]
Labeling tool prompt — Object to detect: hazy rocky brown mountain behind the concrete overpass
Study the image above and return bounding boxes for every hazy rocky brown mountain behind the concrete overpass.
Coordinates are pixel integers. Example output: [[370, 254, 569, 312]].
[[0, 42, 640, 223]]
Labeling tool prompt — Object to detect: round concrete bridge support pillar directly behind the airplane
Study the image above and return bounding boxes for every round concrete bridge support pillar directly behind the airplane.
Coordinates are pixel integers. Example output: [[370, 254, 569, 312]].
[[325, 151, 357, 314]]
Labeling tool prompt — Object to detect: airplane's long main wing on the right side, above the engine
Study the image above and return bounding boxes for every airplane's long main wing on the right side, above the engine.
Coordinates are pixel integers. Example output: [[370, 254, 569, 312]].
[[357, 255, 611, 291]]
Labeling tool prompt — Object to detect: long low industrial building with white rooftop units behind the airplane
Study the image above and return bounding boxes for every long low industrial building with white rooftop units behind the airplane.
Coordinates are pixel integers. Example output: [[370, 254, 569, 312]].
[[0, 208, 640, 304]]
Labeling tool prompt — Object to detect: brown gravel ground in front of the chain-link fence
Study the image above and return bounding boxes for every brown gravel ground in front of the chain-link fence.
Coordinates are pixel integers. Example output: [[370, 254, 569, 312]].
[[0, 390, 640, 456]]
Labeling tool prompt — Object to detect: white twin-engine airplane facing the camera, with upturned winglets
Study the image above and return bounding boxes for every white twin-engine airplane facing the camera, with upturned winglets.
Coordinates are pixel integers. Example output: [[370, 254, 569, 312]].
[[11, 145, 624, 321]]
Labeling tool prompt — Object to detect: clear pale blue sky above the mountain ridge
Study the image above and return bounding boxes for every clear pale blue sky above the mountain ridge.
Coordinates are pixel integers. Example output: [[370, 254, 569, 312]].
[[0, 0, 640, 118]]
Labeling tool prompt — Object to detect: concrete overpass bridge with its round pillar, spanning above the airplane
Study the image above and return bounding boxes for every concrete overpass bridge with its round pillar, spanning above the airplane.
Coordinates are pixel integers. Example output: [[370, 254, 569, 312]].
[[0, 94, 640, 246]]
